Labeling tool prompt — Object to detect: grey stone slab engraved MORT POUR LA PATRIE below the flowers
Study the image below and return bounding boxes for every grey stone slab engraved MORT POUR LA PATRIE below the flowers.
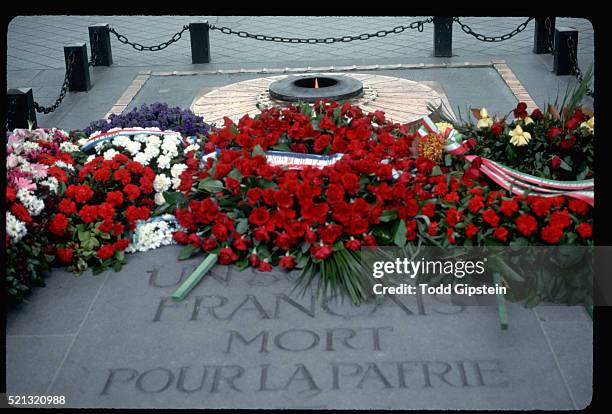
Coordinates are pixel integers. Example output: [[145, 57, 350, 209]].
[[7, 246, 592, 410]]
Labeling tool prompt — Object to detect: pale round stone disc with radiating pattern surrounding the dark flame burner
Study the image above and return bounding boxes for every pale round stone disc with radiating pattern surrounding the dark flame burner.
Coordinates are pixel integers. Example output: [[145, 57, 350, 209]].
[[191, 73, 442, 124]]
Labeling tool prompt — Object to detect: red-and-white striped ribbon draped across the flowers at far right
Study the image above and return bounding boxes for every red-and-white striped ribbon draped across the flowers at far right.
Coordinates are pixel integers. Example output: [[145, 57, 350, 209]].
[[418, 116, 595, 206]]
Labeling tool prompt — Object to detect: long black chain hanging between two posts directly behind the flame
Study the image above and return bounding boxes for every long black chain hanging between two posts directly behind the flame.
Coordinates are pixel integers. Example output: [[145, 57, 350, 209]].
[[208, 17, 433, 44]]
